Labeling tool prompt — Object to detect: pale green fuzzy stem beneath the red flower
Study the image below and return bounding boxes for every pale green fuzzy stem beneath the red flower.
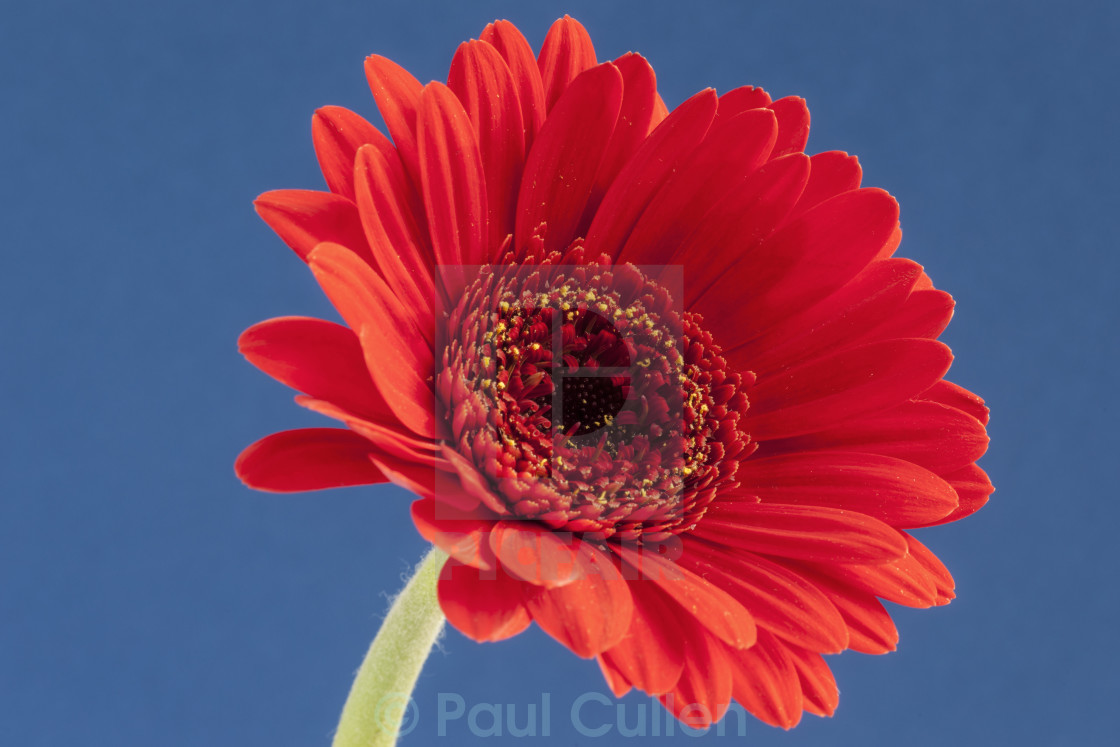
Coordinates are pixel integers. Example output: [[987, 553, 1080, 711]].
[[334, 548, 447, 747]]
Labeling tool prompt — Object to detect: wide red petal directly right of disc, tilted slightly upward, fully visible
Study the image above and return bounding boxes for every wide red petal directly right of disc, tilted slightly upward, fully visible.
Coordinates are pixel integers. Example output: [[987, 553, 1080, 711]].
[[746, 339, 952, 440]]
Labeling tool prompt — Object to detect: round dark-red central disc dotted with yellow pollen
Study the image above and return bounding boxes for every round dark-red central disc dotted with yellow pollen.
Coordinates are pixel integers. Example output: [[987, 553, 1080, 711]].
[[437, 254, 748, 540]]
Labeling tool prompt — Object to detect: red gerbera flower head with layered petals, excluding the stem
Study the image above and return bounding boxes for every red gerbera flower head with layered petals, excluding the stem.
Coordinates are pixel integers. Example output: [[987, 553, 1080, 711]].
[[237, 18, 991, 727]]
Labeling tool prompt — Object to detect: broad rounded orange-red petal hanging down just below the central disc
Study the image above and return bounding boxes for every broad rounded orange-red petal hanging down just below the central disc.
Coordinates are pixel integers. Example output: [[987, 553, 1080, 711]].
[[522, 543, 634, 657]]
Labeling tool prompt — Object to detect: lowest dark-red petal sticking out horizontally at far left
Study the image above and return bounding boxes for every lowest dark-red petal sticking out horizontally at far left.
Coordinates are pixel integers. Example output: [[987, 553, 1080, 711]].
[[234, 428, 388, 493]]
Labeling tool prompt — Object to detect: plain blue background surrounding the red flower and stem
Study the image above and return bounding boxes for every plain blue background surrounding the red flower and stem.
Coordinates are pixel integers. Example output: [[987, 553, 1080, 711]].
[[0, 0, 1120, 745]]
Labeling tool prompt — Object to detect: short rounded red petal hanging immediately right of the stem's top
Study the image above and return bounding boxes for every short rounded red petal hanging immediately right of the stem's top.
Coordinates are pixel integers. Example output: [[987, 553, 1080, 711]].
[[438, 558, 532, 641]]
